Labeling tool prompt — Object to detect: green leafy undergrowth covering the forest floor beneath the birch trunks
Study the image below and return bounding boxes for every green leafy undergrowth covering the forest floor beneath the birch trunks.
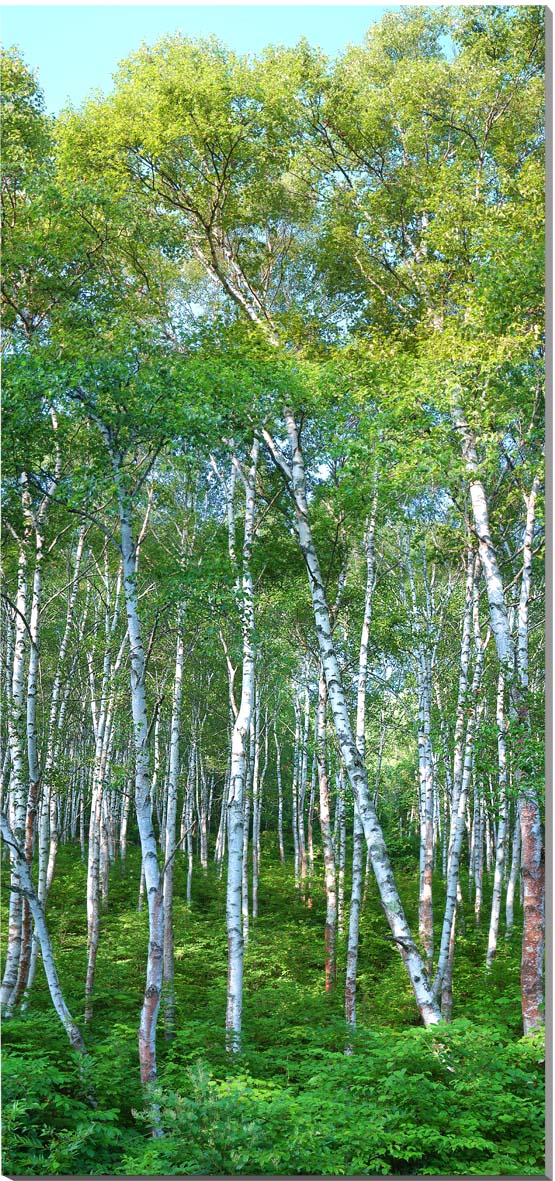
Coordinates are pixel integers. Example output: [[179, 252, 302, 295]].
[[2, 844, 544, 1176]]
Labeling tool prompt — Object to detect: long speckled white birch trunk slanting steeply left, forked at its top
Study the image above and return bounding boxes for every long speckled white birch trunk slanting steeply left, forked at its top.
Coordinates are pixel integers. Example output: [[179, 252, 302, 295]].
[[263, 420, 440, 1025]]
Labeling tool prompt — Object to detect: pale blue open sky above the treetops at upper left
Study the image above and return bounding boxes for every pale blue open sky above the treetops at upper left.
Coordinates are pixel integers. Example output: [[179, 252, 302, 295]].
[[1, 4, 397, 113]]
